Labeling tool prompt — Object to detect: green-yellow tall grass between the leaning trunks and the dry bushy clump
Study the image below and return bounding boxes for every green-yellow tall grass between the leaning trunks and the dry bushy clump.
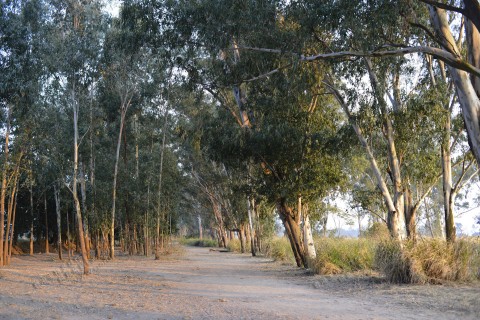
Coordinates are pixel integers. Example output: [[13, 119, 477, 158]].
[[310, 238, 376, 274]]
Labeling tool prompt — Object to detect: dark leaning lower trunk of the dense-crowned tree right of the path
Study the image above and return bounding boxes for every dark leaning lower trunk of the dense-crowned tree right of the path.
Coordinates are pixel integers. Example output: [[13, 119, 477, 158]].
[[277, 198, 307, 267]]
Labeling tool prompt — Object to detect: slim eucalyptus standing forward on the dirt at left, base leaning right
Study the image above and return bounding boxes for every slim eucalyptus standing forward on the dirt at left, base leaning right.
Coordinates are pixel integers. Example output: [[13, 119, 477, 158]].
[[39, 0, 107, 273]]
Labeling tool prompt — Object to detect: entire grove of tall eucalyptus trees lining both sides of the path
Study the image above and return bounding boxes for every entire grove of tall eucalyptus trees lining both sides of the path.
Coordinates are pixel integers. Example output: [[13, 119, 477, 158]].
[[0, 0, 480, 273]]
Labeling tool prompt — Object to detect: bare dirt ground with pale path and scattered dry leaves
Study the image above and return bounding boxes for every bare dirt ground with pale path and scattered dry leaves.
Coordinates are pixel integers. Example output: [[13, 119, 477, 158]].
[[0, 247, 480, 320]]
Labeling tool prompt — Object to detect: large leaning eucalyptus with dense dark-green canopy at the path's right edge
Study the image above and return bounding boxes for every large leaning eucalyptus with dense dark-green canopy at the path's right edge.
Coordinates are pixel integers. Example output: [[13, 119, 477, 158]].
[[156, 1, 350, 265]]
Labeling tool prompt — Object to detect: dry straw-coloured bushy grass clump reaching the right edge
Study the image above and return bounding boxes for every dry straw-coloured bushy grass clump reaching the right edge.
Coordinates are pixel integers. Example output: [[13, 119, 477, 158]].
[[375, 239, 480, 283]]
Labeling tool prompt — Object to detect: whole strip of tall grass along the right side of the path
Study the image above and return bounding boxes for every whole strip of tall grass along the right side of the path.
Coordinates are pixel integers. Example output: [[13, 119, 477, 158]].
[[264, 232, 480, 284]]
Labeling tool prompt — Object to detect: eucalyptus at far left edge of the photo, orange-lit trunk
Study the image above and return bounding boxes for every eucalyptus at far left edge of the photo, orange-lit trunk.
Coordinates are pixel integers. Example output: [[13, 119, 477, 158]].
[[0, 1, 45, 265]]
